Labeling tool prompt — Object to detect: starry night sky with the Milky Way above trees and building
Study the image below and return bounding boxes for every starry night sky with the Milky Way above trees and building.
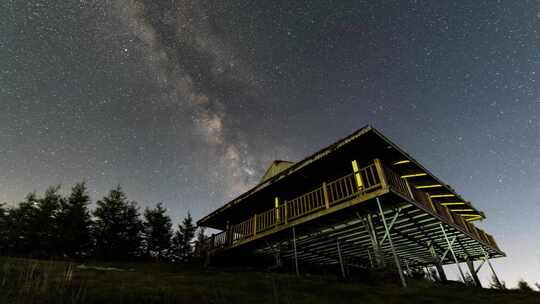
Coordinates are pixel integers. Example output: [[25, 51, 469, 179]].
[[0, 0, 540, 286]]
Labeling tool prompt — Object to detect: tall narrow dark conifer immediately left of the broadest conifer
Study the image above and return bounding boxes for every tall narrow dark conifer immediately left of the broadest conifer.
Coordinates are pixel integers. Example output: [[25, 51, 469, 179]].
[[58, 183, 92, 258]]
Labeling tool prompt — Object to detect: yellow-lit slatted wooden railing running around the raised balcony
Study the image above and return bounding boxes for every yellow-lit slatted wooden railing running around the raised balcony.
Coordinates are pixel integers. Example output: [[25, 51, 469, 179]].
[[205, 160, 498, 253]]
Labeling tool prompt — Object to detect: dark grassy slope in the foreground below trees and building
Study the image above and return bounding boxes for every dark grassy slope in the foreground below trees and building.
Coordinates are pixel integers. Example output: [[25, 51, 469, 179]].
[[0, 258, 540, 304]]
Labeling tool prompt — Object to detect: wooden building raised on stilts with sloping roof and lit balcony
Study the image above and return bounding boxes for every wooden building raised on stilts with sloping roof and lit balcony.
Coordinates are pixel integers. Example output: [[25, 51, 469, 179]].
[[198, 126, 505, 285]]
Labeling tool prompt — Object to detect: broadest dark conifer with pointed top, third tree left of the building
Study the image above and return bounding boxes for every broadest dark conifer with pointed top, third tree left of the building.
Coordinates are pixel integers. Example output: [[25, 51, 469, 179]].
[[94, 186, 143, 260]]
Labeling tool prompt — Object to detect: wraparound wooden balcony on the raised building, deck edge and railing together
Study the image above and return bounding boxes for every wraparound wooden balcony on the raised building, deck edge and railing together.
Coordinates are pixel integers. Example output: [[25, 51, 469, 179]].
[[207, 159, 499, 251]]
